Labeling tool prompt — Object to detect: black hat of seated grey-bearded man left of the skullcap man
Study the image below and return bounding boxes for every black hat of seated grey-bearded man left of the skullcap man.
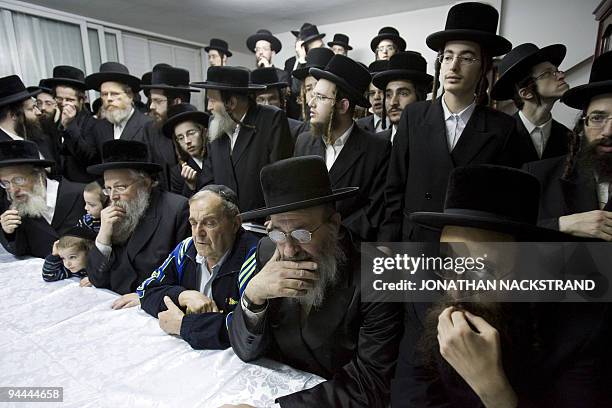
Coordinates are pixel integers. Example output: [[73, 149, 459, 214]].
[[87, 139, 162, 176]]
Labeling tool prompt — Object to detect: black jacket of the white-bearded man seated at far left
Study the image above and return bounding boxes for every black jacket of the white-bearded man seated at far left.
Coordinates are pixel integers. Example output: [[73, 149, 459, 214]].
[[0, 179, 85, 258]]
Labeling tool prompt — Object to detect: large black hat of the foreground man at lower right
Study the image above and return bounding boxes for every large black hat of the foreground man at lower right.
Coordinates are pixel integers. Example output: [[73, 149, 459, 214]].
[[410, 165, 580, 242]]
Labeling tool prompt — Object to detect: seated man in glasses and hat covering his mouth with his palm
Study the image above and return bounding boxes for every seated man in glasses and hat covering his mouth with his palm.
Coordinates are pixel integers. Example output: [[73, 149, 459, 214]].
[[229, 156, 401, 408]]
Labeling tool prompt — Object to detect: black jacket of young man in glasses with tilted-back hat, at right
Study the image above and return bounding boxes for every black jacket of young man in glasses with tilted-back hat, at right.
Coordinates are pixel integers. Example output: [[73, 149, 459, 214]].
[[513, 112, 571, 163]]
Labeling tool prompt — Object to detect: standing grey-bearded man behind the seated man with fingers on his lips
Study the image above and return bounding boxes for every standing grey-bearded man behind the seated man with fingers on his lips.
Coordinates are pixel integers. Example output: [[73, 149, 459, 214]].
[[85, 62, 151, 159]]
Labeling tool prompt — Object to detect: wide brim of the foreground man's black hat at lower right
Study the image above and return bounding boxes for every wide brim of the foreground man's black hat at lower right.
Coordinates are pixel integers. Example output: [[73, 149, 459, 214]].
[[410, 212, 583, 242]]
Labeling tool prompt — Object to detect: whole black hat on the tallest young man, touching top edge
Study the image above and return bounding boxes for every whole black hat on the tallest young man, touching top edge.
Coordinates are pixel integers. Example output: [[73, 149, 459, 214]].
[[425, 2, 512, 57]]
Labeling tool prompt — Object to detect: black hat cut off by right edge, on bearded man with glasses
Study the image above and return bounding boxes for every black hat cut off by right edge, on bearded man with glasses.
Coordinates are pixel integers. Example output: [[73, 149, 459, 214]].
[[561, 51, 612, 109]]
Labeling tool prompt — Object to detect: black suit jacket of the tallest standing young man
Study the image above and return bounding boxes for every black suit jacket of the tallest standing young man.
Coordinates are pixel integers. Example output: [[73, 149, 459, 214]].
[[379, 97, 520, 242]]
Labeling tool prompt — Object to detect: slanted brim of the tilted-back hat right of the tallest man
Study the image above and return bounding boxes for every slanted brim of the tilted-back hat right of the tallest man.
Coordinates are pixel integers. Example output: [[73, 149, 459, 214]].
[[491, 44, 567, 101]]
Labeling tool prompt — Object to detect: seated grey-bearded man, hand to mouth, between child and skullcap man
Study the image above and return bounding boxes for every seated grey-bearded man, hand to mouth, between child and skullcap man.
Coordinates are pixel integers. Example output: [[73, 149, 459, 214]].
[[87, 140, 189, 308]]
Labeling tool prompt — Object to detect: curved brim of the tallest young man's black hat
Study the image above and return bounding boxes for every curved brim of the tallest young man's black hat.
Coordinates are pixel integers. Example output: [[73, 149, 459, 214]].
[[425, 29, 512, 57]]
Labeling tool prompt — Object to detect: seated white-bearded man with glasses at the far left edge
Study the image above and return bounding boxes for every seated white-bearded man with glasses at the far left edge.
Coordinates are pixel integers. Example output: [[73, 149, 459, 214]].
[[0, 140, 85, 258]]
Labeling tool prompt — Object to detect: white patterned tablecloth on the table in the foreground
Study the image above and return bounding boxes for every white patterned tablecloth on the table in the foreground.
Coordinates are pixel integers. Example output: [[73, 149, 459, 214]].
[[0, 259, 322, 408]]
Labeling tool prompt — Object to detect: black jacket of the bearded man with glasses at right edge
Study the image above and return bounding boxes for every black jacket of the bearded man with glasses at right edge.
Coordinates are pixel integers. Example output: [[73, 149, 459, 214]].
[[523, 156, 599, 230]]
